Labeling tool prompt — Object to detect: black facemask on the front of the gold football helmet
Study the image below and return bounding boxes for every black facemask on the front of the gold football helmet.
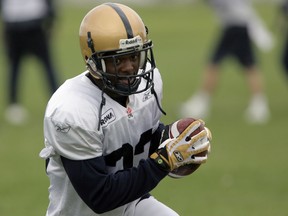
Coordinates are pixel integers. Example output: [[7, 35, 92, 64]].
[[86, 35, 156, 96]]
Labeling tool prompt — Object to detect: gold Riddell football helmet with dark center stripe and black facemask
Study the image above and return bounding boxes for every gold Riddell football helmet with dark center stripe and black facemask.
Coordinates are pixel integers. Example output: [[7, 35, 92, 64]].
[[79, 3, 156, 96]]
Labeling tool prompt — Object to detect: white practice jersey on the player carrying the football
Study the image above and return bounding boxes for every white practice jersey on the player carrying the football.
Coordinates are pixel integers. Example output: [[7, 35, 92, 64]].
[[40, 66, 162, 216]]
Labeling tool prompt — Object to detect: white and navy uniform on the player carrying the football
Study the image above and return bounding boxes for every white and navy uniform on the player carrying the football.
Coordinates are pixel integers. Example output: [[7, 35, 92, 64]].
[[40, 66, 177, 216]]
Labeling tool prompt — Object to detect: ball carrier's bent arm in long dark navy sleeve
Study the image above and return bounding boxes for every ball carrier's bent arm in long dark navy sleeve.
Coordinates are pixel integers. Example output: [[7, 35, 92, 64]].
[[62, 158, 168, 213]]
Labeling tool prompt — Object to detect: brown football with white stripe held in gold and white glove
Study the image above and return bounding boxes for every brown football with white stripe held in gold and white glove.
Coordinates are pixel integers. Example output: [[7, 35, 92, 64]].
[[168, 118, 208, 178]]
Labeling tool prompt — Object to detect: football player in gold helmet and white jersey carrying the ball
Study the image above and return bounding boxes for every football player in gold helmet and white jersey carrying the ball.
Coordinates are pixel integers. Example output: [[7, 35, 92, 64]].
[[40, 3, 210, 216]]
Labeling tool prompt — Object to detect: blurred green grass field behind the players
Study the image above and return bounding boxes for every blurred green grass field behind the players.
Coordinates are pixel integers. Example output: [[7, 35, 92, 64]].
[[0, 3, 288, 216]]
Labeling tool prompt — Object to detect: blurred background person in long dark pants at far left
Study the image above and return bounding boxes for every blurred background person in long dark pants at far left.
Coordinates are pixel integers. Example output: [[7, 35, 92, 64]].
[[0, 0, 58, 124]]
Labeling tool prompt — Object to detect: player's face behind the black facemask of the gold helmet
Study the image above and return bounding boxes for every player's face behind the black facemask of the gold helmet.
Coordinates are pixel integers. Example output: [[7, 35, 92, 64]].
[[105, 52, 140, 85]]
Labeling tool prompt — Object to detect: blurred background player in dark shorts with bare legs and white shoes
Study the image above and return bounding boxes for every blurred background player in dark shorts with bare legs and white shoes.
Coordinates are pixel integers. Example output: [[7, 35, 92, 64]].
[[181, 0, 273, 123]]
